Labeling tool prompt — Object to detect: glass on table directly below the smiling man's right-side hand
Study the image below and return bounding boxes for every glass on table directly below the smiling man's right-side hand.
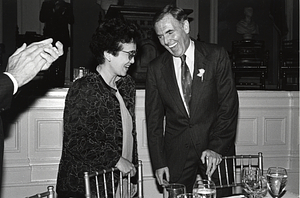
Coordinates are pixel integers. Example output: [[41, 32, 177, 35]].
[[193, 179, 217, 198]]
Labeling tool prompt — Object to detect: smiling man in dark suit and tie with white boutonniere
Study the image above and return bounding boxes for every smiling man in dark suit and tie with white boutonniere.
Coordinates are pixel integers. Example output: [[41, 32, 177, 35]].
[[145, 5, 238, 197]]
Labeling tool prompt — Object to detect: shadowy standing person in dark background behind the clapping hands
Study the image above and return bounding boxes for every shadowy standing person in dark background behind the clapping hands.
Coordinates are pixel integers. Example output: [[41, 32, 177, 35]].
[[40, 0, 74, 87]]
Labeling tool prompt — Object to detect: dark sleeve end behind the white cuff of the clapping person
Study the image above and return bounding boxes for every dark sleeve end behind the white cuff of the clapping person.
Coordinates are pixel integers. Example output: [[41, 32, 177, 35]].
[[0, 74, 14, 112]]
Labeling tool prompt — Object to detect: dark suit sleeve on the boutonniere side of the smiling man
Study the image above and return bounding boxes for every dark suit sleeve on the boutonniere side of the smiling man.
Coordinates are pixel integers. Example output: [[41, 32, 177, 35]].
[[208, 48, 239, 155]]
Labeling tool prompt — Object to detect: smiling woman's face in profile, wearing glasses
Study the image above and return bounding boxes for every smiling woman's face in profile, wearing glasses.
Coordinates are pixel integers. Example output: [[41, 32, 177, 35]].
[[111, 43, 136, 76]]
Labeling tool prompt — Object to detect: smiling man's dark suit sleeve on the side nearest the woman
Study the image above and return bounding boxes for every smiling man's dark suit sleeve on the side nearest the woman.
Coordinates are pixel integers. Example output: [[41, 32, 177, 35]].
[[145, 62, 167, 171]]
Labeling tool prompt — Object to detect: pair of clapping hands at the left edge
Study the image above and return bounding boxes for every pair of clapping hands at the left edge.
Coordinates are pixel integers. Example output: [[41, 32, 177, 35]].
[[6, 38, 63, 87]]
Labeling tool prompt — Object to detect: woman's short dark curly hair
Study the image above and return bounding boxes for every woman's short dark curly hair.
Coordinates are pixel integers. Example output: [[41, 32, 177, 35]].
[[90, 18, 140, 64]]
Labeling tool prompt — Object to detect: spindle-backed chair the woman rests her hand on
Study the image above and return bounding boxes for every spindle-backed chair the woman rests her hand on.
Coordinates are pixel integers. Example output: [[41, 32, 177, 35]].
[[84, 160, 144, 198]]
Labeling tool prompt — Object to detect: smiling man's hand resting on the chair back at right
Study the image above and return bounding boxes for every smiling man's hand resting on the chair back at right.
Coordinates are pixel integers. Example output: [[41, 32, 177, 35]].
[[201, 149, 222, 177]]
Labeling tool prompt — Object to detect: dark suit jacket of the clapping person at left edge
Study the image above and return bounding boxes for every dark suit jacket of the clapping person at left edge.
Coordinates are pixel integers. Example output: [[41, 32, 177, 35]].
[[0, 73, 14, 190]]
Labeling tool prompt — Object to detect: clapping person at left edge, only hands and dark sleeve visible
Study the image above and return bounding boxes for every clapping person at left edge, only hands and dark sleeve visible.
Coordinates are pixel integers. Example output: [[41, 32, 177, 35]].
[[0, 39, 63, 191]]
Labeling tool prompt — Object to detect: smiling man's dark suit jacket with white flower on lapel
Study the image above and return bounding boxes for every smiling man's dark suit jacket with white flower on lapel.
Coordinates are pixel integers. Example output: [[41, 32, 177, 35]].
[[145, 41, 239, 181]]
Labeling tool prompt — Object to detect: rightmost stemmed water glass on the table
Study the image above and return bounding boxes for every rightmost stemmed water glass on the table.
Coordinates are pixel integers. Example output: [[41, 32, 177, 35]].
[[267, 167, 288, 197]]
